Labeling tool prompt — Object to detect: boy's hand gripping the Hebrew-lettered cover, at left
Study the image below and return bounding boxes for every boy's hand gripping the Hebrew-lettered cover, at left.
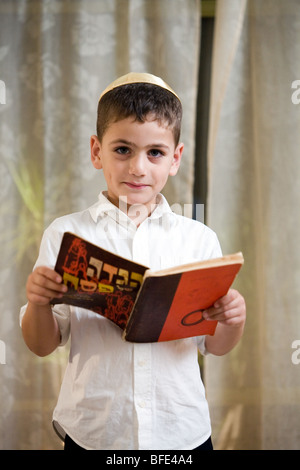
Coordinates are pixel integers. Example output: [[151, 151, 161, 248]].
[[26, 266, 68, 306]]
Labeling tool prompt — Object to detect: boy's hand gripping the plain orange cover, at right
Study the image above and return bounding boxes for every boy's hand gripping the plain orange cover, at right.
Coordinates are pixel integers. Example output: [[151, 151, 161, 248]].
[[203, 289, 246, 327]]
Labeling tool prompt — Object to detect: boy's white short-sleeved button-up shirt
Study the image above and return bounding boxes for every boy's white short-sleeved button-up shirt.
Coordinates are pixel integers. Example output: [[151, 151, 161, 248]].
[[21, 193, 221, 450]]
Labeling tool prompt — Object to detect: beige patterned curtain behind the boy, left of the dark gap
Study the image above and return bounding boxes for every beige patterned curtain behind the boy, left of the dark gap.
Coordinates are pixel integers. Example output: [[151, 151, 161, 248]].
[[0, 0, 200, 450]]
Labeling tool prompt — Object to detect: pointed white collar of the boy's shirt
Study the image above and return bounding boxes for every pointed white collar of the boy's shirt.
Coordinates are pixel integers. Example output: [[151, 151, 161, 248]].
[[89, 191, 172, 223]]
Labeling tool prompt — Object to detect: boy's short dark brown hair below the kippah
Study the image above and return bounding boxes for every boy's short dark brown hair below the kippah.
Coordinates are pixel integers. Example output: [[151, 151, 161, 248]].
[[97, 83, 182, 146]]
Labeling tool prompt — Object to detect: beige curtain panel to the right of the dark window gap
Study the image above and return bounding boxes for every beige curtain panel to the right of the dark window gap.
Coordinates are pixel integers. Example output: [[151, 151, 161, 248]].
[[206, 0, 300, 450]]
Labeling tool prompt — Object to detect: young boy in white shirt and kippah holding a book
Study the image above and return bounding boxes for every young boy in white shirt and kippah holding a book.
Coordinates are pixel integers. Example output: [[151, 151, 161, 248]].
[[21, 74, 246, 450]]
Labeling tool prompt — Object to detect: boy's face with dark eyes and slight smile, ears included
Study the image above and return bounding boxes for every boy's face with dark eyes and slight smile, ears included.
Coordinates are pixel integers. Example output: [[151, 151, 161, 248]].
[[91, 117, 183, 219]]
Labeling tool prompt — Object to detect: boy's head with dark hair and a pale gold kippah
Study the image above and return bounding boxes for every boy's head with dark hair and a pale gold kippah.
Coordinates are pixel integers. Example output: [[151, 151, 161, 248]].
[[91, 74, 183, 223]]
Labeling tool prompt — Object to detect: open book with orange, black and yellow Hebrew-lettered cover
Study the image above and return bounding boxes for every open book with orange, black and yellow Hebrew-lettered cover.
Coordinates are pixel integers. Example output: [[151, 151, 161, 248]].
[[52, 232, 244, 343]]
